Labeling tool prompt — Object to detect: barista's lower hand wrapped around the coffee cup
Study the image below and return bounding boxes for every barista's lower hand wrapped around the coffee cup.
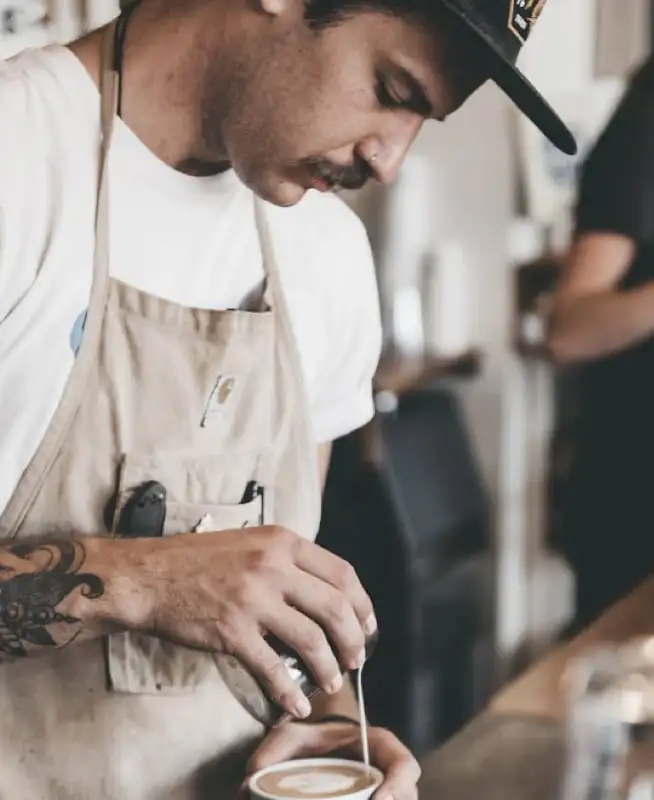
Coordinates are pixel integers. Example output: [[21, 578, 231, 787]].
[[247, 722, 420, 800]]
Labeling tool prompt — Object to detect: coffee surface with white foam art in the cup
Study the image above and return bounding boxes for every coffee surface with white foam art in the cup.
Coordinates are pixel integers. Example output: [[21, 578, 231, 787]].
[[257, 765, 375, 800]]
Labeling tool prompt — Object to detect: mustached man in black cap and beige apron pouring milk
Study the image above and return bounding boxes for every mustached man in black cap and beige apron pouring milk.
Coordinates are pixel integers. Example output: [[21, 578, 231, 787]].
[[0, 0, 574, 800]]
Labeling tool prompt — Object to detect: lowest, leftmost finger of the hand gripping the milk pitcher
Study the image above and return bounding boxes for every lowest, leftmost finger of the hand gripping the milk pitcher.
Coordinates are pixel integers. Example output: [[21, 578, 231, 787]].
[[231, 623, 311, 719]]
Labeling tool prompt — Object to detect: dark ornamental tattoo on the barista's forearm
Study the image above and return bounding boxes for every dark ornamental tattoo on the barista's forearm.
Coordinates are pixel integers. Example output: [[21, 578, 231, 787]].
[[0, 541, 104, 661]]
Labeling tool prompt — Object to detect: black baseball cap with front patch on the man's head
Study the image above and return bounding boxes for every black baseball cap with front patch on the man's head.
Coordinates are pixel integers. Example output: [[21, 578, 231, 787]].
[[441, 0, 577, 155]]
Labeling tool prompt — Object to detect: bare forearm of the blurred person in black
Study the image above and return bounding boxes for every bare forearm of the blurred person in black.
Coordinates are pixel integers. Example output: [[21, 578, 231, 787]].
[[548, 283, 654, 363]]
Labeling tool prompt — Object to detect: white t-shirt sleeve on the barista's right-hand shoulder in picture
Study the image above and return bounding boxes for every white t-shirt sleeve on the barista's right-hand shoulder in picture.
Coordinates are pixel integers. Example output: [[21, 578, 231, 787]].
[[311, 207, 382, 443]]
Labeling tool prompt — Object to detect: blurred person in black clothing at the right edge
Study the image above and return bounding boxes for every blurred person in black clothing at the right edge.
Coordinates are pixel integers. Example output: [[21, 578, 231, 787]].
[[549, 54, 654, 627]]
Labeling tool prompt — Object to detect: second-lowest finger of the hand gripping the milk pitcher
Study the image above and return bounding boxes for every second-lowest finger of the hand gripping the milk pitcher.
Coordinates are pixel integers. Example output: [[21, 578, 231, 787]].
[[261, 606, 343, 694]]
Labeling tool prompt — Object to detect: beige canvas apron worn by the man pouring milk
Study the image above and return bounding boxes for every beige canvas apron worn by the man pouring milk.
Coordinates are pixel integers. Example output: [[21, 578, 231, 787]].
[[0, 18, 320, 800]]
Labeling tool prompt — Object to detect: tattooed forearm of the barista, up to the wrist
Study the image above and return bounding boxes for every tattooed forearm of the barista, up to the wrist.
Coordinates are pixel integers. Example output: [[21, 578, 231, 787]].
[[0, 537, 144, 661]]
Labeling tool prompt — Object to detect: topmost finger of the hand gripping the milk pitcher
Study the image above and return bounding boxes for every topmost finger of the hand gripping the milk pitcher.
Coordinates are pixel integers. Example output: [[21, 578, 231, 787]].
[[296, 539, 377, 636]]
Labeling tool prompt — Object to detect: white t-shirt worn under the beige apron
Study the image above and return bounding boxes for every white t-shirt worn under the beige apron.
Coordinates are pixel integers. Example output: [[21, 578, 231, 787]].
[[0, 46, 381, 511]]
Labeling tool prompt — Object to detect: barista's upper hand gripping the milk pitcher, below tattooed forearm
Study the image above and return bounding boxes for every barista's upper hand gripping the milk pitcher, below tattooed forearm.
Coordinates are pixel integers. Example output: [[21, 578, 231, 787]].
[[116, 527, 376, 717]]
